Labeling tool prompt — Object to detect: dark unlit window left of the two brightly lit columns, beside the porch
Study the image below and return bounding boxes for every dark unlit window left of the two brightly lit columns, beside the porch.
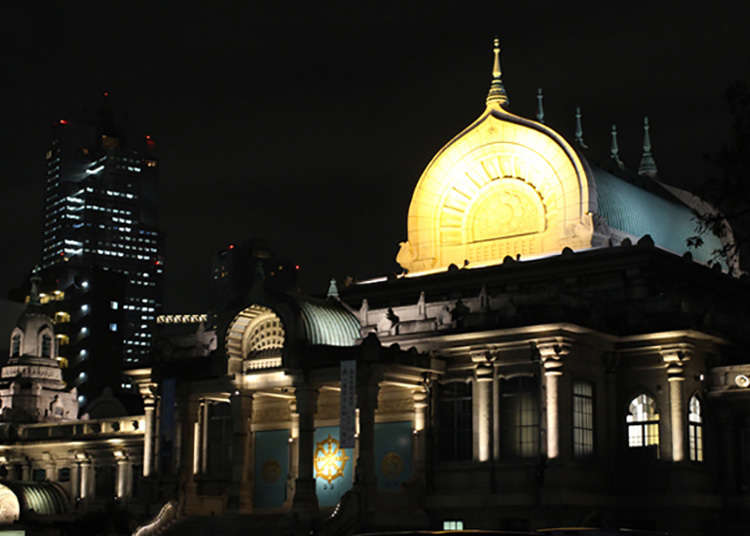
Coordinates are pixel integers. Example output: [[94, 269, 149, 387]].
[[439, 381, 472, 461]]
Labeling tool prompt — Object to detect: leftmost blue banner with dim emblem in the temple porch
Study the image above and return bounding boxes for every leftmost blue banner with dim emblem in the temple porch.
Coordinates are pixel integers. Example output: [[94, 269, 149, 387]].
[[253, 430, 289, 508]]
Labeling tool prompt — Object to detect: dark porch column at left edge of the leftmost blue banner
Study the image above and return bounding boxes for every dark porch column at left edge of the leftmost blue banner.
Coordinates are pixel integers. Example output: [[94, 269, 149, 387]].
[[228, 391, 255, 512]]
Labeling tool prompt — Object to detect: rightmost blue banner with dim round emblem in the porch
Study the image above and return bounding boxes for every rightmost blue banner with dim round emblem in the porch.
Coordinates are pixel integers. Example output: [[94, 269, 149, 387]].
[[375, 421, 412, 491]]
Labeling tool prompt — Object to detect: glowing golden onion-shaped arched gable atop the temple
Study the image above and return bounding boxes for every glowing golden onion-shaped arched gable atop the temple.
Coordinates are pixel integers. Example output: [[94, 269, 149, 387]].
[[396, 108, 596, 272]]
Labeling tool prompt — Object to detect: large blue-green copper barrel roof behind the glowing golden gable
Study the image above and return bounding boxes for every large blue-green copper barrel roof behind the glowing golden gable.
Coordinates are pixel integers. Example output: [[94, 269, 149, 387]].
[[592, 166, 721, 263]]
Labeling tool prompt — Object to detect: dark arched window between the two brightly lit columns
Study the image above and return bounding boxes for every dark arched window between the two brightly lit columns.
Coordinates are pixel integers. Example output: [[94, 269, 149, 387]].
[[500, 376, 539, 458]]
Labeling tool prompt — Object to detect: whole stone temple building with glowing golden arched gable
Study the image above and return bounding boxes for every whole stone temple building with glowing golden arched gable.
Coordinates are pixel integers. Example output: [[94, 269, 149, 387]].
[[2, 37, 750, 536]]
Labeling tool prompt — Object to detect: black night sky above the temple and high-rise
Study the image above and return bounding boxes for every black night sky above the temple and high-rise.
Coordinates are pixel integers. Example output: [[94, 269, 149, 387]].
[[0, 2, 750, 312]]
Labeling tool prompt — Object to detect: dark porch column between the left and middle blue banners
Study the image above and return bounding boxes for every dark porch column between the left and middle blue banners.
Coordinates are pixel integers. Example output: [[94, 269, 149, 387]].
[[292, 385, 318, 519]]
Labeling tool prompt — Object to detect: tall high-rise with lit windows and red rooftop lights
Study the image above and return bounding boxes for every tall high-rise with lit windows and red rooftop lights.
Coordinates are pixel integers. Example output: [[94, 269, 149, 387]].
[[38, 93, 164, 406]]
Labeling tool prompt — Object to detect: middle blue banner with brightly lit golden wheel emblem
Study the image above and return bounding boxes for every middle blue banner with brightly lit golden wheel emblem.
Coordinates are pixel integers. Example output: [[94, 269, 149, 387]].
[[313, 426, 354, 506]]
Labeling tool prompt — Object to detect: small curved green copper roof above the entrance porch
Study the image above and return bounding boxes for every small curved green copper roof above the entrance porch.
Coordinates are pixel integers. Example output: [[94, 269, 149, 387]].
[[299, 299, 360, 346]]
